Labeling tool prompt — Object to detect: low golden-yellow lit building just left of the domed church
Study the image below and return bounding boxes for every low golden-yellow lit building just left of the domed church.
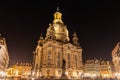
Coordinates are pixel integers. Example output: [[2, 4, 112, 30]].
[[6, 63, 32, 78]]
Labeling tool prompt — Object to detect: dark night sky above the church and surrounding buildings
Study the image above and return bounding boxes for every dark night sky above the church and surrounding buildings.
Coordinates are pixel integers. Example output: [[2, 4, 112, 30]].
[[0, 0, 120, 66]]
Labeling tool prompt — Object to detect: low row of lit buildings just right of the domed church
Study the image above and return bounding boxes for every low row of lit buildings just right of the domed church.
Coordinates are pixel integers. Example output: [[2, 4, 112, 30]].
[[83, 59, 114, 78]]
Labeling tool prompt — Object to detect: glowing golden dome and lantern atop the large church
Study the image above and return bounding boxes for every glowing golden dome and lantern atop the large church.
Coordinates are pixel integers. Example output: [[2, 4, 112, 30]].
[[46, 9, 69, 42]]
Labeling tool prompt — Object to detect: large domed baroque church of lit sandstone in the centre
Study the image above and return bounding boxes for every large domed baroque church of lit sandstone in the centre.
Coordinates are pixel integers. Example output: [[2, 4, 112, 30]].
[[33, 9, 83, 79]]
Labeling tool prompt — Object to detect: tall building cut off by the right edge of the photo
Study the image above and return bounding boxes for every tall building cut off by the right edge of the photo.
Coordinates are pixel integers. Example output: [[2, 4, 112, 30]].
[[112, 42, 120, 79]]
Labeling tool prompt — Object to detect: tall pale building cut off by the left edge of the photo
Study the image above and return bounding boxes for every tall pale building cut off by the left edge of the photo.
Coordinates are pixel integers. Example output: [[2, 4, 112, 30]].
[[0, 35, 9, 77]]
